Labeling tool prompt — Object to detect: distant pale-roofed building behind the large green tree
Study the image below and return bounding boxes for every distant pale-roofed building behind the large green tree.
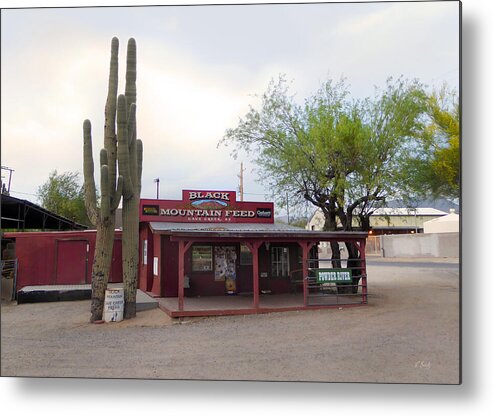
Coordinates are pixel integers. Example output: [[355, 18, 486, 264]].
[[306, 208, 448, 235]]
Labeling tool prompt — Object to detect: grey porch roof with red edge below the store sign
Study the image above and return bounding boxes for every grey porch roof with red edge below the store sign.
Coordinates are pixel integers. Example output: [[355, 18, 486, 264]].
[[149, 222, 368, 241]]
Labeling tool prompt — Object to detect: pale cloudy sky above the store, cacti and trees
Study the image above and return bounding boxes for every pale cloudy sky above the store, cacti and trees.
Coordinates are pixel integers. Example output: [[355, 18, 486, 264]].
[[1, 1, 459, 214]]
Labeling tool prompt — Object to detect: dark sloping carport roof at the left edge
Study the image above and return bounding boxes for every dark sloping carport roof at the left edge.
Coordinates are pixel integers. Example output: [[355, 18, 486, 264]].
[[0, 194, 88, 231]]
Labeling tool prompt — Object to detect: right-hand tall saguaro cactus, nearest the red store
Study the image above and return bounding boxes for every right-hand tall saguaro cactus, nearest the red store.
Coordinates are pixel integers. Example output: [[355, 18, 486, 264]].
[[117, 38, 143, 319]]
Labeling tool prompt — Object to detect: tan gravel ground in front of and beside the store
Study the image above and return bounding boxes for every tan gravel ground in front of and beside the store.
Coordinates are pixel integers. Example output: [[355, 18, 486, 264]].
[[1, 262, 459, 384]]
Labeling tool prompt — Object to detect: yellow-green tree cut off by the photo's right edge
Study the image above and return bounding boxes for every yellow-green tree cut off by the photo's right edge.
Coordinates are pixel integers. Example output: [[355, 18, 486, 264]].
[[405, 85, 460, 199]]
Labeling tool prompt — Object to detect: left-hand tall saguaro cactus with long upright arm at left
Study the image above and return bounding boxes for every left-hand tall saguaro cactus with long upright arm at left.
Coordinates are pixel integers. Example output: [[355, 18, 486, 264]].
[[83, 37, 123, 322]]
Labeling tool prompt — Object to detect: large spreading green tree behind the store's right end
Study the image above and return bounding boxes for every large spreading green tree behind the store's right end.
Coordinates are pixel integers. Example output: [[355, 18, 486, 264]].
[[220, 77, 425, 292]]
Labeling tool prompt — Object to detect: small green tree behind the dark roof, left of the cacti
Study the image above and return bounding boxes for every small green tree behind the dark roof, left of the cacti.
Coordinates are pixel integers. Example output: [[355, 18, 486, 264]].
[[38, 170, 91, 225]]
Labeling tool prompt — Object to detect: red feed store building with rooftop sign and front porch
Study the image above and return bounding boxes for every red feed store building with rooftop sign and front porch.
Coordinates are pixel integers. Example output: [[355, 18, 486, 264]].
[[139, 190, 367, 316]]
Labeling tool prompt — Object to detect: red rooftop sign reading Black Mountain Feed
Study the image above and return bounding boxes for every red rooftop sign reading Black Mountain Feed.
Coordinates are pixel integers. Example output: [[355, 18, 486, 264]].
[[140, 190, 274, 223]]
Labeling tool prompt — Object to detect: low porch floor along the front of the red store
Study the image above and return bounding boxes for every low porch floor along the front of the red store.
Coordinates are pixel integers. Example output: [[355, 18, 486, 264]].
[[156, 293, 364, 318]]
